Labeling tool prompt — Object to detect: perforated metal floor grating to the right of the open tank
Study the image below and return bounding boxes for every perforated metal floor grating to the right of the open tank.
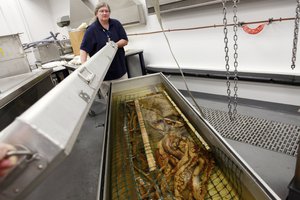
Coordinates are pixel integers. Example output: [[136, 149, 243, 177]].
[[202, 107, 300, 156]]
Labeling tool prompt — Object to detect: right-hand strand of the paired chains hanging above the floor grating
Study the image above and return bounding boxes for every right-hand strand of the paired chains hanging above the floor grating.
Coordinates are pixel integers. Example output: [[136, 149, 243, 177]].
[[232, 0, 239, 119]]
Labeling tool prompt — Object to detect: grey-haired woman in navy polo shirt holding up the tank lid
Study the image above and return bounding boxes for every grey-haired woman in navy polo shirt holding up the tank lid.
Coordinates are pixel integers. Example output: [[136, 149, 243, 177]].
[[80, 2, 128, 97]]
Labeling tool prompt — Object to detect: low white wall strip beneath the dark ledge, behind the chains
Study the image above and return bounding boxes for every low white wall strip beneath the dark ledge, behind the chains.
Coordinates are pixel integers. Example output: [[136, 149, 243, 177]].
[[168, 76, 300, 106]]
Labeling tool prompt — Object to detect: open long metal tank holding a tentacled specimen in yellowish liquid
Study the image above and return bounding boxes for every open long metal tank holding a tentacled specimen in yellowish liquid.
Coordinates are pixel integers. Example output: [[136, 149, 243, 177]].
[[98, 73, 280, 199]]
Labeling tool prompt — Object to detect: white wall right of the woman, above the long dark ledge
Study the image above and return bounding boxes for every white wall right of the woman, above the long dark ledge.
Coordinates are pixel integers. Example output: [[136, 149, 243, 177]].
[[126, 0, 300, 75]]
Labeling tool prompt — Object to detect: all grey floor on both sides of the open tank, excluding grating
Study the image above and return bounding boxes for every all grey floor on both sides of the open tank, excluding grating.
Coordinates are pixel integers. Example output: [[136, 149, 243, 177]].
[[25, 88, 300, 200]]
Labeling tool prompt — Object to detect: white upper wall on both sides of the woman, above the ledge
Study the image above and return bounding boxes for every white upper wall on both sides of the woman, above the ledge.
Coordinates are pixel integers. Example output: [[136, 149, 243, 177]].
[[0, 0, 300, 75]]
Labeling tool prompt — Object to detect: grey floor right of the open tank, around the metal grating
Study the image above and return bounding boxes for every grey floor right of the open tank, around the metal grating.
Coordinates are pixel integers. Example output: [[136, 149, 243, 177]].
[[185, 92, 300, 199]]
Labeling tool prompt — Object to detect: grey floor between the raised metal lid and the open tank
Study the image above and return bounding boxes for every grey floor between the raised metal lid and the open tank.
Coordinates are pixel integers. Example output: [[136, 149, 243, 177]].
[[24, 102, 106, 200]]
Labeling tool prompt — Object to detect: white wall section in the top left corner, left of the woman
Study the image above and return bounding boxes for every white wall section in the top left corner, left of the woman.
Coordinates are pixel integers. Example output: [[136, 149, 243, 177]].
[[0, 0, 54, 43]]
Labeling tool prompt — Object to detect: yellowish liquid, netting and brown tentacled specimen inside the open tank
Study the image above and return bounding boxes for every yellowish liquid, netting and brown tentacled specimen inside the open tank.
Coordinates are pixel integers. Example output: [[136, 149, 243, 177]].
[[110, 85, 242, 199]]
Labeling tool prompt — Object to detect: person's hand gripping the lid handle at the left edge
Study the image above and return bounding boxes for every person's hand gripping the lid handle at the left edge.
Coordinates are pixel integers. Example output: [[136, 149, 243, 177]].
[[0, 143, 17, 177]]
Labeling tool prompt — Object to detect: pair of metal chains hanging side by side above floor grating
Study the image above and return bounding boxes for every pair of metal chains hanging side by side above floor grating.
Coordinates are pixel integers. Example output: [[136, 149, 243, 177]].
[[222, 0, 239, 120]]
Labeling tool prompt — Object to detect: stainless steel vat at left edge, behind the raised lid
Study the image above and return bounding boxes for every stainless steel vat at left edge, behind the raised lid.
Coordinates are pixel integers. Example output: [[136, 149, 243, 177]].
[[0, 69, 54, 131]]
